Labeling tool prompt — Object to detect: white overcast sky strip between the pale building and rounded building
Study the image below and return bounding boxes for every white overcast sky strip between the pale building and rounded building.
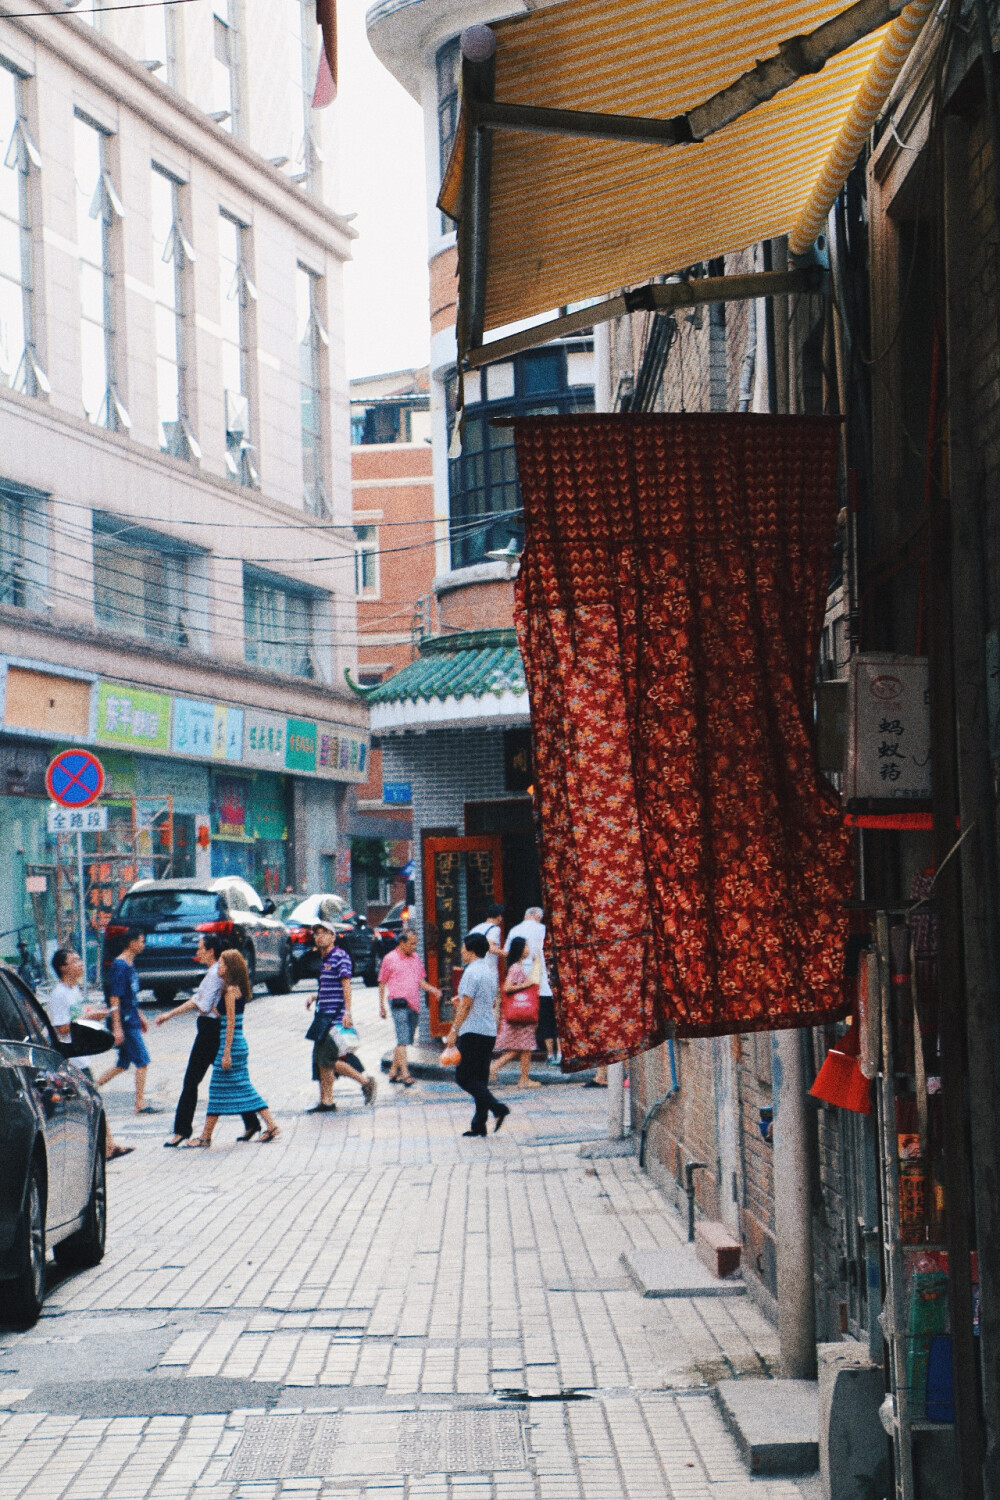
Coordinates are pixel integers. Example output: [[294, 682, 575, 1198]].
[[333, 0, 429, 378]]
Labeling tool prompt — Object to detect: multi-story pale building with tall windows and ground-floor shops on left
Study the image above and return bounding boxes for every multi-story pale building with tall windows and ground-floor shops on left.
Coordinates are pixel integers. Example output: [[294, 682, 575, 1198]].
[[0, 0, 367, 972]]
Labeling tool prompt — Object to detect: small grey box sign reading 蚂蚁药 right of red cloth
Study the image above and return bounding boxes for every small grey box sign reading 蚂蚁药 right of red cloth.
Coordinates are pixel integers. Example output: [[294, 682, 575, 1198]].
[[844, 654, 931, 804]]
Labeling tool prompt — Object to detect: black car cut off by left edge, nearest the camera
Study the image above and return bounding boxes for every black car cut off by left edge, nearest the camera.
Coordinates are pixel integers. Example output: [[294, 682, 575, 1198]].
[[0, 965, 111, 1328]]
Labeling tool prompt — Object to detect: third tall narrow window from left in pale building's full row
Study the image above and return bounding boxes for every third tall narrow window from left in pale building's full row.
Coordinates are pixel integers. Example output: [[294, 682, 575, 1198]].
[[151, 165, 201, 459]]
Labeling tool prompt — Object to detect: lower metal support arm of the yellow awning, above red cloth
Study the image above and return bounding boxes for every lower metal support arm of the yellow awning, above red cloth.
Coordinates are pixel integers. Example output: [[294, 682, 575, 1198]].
[[465, 266, 828, 369]]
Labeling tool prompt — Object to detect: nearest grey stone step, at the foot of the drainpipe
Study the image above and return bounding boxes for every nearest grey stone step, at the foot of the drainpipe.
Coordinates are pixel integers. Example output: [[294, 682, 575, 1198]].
[[714, 1380, 820, 1475]]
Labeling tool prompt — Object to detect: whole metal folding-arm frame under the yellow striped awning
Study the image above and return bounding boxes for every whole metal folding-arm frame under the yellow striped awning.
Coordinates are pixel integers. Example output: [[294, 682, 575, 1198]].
[[452, 0, 906, 357]]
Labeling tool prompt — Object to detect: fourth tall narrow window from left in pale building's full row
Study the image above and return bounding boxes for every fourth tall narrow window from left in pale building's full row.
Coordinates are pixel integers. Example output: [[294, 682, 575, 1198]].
[[219, 213, 259, 489]]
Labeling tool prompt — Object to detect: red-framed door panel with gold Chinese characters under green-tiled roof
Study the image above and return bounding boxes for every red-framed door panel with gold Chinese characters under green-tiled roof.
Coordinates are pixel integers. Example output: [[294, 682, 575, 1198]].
[[424, 834, 504, 1037]]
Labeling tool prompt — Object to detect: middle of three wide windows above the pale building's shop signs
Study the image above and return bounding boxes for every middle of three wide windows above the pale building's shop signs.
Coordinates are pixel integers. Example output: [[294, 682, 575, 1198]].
[[93, 515, 199, 648]]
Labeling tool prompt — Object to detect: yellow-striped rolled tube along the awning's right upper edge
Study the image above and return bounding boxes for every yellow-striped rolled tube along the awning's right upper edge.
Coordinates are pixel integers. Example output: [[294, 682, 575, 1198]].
[[789, 0, 936, 255]]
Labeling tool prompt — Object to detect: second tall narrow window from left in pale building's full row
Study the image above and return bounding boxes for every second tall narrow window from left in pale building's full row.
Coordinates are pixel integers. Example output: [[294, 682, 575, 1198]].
[[73, 116, 125, 431]]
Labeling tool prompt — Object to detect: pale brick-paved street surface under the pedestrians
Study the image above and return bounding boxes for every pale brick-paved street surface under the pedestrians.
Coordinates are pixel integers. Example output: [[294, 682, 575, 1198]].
[[0, 992, 820, 1500]]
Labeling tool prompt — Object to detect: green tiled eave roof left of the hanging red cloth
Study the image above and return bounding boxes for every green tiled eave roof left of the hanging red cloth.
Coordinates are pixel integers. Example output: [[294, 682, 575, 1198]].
[[364, 630, 528, 704]]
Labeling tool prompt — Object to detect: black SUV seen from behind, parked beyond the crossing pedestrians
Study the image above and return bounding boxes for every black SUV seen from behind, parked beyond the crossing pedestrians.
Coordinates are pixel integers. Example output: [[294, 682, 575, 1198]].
[[102, 875, 295, 1004]]
